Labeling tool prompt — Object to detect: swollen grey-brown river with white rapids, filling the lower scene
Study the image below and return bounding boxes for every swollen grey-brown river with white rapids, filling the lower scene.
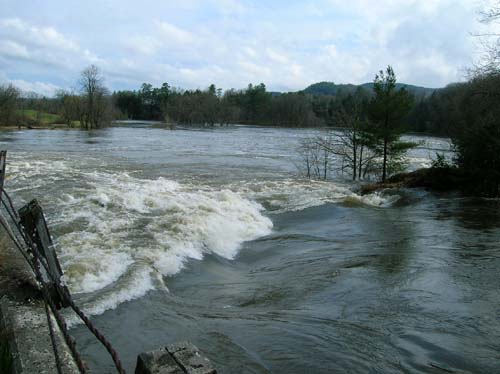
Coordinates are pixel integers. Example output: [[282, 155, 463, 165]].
[[0, 123, 500, 374]]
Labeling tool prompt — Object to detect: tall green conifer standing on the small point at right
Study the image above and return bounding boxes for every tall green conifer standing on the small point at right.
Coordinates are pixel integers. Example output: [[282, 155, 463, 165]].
[[367, 66, 415, 182]]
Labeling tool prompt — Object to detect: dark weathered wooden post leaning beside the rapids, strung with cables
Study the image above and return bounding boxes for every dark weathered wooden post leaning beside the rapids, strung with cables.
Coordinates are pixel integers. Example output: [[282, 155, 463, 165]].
[[19, 200, 69, 309]]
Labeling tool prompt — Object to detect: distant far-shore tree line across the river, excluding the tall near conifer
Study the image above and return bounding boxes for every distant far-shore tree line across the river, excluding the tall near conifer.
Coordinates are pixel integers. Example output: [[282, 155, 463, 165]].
[[0, 62, 496, 136]]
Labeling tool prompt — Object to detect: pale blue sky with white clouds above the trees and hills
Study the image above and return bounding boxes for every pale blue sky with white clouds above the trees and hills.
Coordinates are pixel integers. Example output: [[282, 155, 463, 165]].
[[0, 0, 492, 94]]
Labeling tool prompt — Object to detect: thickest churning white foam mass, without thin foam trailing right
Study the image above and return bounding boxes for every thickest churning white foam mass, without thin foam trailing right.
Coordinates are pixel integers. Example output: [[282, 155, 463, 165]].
[[49, 172, 272, 314]]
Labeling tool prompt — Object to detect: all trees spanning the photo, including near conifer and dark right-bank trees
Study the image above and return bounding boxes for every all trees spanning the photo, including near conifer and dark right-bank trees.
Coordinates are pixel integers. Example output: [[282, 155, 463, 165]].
[[0, 1, 500, 196]]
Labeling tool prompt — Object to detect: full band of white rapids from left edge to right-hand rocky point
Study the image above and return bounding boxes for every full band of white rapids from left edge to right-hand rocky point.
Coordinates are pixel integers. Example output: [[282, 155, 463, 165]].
[[8, 155, 397, 315]]
